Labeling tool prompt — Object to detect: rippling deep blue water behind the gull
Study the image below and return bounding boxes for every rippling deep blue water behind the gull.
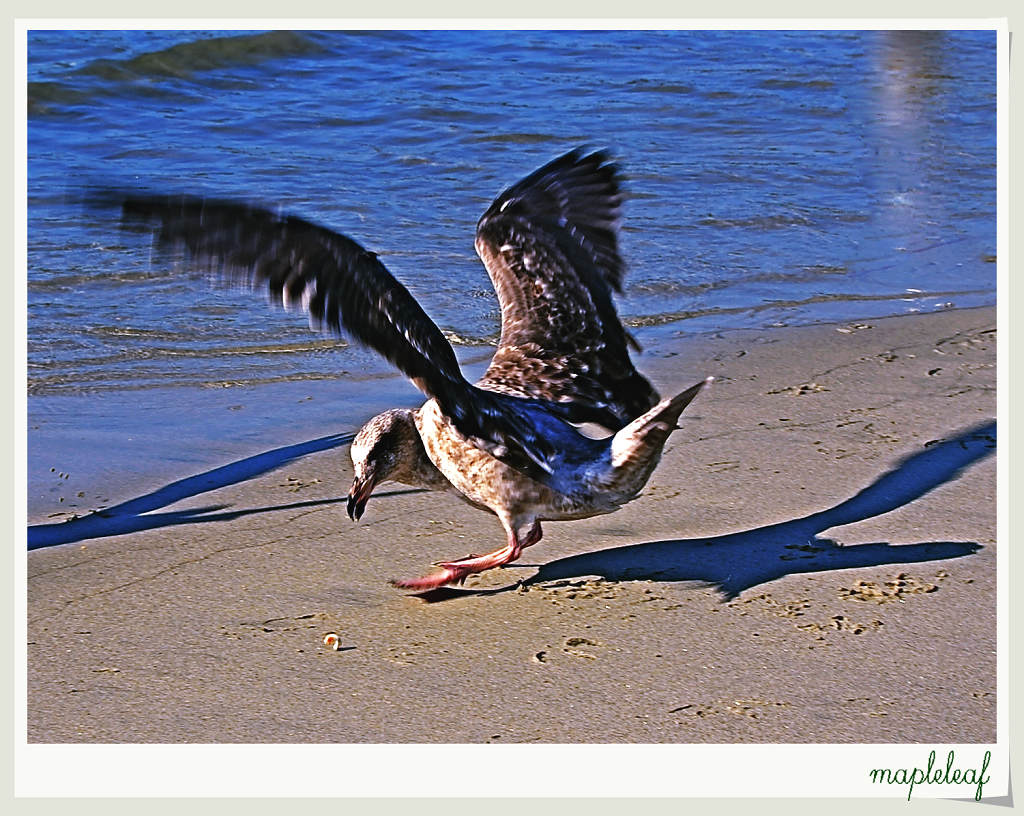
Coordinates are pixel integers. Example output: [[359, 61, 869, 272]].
[[28, 31, 996, 516]]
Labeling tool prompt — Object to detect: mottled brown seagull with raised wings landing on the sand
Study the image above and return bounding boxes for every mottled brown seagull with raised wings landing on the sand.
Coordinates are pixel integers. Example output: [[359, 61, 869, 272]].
[[105, 148, 712, 592]]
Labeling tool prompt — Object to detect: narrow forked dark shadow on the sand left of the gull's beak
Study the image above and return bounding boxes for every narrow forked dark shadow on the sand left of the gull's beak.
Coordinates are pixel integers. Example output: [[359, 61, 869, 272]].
[[29, 433, 364, 550]]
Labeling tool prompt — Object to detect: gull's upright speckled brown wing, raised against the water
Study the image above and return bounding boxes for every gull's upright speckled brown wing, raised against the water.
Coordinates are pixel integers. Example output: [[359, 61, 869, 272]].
[[476, 149, 657, 430]]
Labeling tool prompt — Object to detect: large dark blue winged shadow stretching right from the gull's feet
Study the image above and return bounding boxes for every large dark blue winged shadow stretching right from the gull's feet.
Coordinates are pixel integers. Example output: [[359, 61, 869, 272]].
[[418, 422, 995, 602]]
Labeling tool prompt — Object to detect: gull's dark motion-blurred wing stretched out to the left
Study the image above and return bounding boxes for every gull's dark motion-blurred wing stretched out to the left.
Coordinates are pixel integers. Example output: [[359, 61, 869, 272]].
[[101, 191, 552, 474]]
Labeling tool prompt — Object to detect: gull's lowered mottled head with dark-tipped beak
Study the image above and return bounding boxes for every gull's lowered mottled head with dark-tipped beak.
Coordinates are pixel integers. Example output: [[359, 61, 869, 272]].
[[348, 409, 417, 521]]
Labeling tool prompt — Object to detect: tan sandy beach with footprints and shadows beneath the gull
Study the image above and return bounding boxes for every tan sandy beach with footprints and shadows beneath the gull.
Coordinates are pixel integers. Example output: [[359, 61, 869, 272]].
[[28, 309, 996, 743]]
